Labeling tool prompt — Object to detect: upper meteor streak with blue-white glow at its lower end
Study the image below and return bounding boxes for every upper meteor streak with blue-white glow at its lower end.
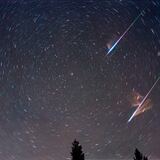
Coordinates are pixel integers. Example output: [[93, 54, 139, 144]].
[[107, 11, 143, 55]]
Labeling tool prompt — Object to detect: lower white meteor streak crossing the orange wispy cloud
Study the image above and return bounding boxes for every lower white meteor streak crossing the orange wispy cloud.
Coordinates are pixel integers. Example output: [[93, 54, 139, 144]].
[[128, 77, 160, 123]]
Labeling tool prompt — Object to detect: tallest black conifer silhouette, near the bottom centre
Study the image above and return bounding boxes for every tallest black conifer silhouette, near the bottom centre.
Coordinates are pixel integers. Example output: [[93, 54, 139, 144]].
[[71, 140, 84, 160]]
